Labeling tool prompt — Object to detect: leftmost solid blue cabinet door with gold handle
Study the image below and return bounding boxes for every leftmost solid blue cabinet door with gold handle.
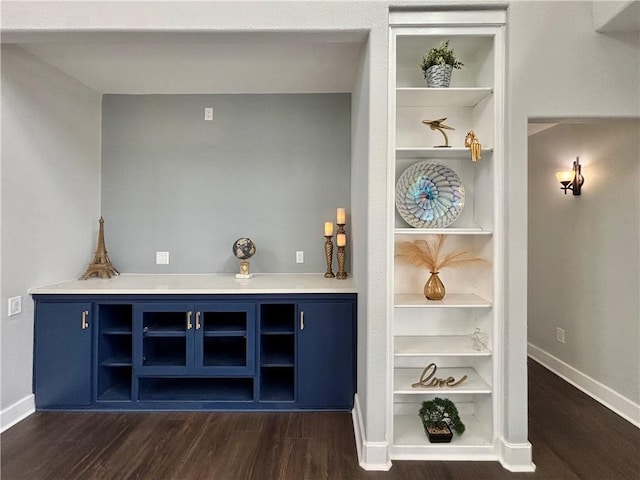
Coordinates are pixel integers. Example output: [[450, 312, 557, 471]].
[[34, 302, 93, 408]]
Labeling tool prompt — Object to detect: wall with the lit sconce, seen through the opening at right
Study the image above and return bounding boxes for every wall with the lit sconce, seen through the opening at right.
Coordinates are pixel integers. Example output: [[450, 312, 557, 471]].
[[528, 120, 640, 416]]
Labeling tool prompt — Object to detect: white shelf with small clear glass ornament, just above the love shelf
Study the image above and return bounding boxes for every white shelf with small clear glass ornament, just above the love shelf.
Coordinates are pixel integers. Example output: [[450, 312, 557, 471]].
[[393, 335, 491, 358]]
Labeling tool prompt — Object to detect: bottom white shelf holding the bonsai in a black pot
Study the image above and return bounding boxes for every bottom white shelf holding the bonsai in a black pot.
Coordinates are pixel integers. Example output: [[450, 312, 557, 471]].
[[391, 412, 494, 460]]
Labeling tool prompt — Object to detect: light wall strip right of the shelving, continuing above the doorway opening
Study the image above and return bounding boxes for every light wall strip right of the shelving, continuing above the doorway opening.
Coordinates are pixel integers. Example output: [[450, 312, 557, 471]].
[[504, 1, 640, 443]]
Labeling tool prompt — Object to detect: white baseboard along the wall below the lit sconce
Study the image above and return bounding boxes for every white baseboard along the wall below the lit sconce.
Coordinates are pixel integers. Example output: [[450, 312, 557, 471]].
[[528, 343, 640, 428]]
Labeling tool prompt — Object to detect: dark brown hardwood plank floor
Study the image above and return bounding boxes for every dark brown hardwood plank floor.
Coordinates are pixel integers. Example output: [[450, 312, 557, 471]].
[[0, 361, 640, 480]]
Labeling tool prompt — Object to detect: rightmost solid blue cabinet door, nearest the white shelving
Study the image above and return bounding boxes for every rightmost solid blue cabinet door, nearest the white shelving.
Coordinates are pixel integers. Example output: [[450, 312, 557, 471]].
[[297, 302, 355, 409]]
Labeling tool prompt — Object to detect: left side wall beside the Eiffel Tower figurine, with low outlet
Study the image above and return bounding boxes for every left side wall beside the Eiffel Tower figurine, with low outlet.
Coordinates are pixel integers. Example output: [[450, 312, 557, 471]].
[[0, 45, 101, 425]]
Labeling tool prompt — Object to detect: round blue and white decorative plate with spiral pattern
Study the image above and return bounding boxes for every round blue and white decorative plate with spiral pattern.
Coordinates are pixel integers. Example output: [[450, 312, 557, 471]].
[[396, 161, 464, 228]]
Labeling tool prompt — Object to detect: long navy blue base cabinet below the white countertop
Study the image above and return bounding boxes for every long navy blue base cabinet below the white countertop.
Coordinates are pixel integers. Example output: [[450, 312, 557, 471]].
[[34, 294, 356, 410]]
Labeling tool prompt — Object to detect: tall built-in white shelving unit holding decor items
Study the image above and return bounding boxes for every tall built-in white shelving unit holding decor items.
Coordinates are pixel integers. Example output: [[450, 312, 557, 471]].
[[387, 9, 506, 460]]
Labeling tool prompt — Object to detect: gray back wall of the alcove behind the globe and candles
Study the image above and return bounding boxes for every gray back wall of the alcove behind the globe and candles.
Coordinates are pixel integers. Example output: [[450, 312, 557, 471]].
[[102, 94, 351, 273]]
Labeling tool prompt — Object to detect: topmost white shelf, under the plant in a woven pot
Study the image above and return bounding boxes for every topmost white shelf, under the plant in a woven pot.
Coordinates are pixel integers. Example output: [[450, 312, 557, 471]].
[[396, 87, 493, 107]]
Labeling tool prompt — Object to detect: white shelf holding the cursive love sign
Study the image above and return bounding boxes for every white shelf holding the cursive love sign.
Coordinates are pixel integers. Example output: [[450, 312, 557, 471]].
[[393, 368, 491, 395]]
